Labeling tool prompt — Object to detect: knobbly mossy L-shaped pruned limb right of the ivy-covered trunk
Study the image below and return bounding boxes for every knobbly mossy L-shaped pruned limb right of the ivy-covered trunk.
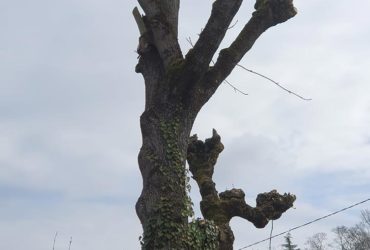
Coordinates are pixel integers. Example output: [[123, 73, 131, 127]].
[[187, 130, 296, 249]]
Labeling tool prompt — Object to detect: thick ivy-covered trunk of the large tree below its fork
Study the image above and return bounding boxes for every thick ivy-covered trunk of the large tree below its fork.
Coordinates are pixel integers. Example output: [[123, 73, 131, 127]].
[[136, 100, 194, 249]]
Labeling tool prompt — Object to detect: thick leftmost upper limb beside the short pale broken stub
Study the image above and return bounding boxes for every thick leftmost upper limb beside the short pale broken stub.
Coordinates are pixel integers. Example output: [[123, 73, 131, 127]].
[[138, 0, 183, 66]]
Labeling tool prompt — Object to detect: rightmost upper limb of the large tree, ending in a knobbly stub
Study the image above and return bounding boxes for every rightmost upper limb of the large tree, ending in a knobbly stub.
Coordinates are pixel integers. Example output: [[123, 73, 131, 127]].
[[204, 0, 297, 94]]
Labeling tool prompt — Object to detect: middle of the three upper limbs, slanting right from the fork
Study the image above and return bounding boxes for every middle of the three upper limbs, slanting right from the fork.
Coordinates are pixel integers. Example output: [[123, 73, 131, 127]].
[[186, 0, 243, 76]]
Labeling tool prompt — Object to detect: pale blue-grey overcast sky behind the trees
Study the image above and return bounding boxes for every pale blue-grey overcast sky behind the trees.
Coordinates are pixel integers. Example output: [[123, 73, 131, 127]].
[[0, 0, 370, 250]]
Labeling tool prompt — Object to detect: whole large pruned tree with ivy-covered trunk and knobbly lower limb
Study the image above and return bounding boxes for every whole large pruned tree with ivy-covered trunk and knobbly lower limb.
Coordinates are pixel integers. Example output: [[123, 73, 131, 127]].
[[134, 0, 296, 249]]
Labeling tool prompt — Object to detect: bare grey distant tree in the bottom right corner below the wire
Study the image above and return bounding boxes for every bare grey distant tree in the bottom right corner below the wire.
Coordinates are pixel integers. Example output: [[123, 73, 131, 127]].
[[333, 210, 370, 250]]
